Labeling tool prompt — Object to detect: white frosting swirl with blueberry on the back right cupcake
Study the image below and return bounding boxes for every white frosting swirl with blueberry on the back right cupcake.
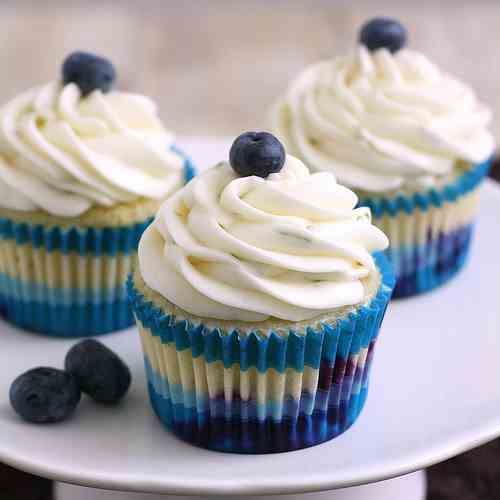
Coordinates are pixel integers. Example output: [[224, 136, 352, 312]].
[[272, 19, 494, 193]]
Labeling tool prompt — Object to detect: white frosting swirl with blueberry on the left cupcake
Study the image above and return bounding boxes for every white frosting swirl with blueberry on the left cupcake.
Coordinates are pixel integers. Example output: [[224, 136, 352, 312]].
[[0, 53, 183, 217]]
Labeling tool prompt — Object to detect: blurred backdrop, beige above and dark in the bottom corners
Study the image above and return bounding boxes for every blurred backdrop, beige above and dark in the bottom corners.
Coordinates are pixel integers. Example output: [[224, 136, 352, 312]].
[[0, 0, 500, 500]]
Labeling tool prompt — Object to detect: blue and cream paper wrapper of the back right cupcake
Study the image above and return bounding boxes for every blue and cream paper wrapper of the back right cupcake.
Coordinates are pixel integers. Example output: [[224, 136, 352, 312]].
[[359, 160, 491, 298]]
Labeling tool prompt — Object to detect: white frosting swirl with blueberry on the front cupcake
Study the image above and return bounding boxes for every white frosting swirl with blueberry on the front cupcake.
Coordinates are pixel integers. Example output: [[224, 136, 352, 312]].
[[139, 132, 388, 322]]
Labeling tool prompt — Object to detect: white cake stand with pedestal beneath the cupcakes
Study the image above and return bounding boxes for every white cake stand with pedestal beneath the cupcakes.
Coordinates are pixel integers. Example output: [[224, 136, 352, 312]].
[[0, 141, 500, 500]]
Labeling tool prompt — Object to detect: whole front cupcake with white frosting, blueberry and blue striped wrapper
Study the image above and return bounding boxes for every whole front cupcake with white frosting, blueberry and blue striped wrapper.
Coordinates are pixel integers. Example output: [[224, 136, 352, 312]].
[[128, 132, 394, 453]]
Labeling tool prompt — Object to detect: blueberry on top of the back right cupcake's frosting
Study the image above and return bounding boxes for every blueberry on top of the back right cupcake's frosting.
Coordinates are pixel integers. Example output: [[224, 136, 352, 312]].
[[359, 17, 407, 53]]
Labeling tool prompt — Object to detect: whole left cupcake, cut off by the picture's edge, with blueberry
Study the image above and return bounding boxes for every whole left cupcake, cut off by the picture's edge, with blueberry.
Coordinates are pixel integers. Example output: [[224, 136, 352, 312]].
[[0, 52, 193, 337]]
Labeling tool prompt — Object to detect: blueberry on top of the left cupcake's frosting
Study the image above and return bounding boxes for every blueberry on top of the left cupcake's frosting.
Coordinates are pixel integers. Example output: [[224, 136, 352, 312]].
[[62, 52, 116, 96]]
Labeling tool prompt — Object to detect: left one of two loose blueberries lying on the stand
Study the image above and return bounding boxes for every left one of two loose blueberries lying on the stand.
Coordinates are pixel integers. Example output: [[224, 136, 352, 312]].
[[9, 367, 81, 424]]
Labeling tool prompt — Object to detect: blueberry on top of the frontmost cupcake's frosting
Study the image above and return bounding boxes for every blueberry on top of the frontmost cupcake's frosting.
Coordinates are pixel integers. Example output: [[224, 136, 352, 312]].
[[229, 132, 286, 178]]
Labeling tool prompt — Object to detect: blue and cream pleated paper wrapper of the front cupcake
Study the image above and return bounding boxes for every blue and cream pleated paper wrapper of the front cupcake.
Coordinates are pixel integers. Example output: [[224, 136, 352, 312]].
[[128, 254, 394, 453]]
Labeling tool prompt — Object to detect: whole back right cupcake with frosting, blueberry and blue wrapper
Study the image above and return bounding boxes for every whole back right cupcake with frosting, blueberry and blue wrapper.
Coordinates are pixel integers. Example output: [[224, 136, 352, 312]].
[[272, 19, 494, 297]]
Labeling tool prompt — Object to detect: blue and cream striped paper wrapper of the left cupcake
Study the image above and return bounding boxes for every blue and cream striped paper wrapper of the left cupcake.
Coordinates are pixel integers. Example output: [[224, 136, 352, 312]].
[[0, 143, 195, 337]]
